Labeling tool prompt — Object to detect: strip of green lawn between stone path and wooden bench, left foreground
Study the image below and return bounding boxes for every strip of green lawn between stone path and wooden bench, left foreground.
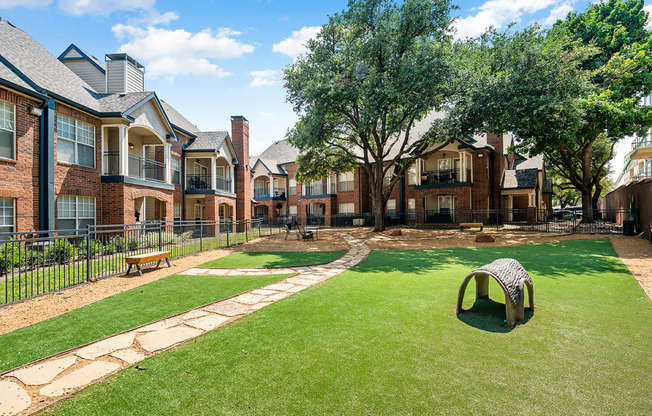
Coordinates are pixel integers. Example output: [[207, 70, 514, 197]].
[[0, 275, 289, 372]]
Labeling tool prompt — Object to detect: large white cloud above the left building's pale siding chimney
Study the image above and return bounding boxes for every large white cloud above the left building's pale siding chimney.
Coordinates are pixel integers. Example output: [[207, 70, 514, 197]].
[[112, 24, 254, 81]]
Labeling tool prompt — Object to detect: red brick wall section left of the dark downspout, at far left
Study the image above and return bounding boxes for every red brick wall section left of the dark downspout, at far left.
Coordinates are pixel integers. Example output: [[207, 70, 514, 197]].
[[0, 88, 41, 231]]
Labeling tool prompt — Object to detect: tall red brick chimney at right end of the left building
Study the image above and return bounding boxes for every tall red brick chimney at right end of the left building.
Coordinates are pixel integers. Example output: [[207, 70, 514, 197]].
[[231, 116, 251, 221]]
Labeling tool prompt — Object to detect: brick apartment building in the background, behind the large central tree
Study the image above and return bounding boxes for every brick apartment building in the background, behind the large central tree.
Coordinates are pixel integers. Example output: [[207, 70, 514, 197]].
[[251, 113, 552, 225]]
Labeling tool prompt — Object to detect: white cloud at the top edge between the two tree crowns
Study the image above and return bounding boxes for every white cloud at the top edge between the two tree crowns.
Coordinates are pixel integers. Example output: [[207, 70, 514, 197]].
[[455, 0, 561, 38]]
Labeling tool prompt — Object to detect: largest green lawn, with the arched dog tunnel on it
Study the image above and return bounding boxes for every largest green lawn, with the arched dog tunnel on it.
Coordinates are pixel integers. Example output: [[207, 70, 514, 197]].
[[47, 240, 652, 415]]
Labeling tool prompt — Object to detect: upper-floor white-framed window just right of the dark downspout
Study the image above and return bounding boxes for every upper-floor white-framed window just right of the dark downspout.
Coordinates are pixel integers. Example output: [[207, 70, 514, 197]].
[[57, 114, 95, 168]]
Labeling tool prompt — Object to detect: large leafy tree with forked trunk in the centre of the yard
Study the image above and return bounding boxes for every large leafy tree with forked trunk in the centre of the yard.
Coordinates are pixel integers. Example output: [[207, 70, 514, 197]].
[[284, 0, 452, 231]]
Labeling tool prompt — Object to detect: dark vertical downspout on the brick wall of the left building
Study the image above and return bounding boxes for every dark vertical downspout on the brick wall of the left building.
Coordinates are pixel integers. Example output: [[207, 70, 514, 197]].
[[39, 98, 55, 230]]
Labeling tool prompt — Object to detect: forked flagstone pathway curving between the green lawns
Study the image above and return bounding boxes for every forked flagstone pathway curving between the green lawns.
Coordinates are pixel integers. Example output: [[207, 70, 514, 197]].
[[0, 233, 370, 416]]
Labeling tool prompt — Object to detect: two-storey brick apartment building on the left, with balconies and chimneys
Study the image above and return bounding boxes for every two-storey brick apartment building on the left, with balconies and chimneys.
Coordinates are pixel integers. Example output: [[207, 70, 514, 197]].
[[0, 19, 251, 231]]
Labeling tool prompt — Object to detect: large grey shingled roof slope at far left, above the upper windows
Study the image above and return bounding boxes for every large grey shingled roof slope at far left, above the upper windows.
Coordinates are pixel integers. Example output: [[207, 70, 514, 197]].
[[0, 19, 99, 112]]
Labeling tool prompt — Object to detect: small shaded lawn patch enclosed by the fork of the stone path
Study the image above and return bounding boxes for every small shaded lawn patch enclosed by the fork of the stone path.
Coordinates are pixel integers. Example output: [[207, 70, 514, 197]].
[[197, 251, 344, 269]]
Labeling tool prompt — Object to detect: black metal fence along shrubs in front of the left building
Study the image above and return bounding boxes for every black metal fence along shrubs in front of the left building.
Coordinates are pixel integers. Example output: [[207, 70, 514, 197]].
[[0, 220, 281, 304]]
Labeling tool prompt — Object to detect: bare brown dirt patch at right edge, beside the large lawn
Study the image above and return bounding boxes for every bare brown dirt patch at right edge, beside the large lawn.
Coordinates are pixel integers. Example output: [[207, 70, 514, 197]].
[[611, 235, 652, 300]]
